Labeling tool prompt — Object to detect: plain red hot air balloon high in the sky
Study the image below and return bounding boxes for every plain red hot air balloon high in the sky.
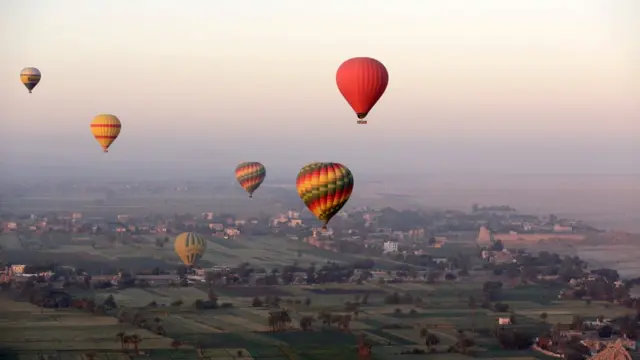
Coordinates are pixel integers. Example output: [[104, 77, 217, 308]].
[[336, 57, 389, 124]]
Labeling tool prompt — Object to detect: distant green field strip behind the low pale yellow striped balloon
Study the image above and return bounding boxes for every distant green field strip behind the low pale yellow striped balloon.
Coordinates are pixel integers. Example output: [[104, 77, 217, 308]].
[[0, 233, 378, 272]]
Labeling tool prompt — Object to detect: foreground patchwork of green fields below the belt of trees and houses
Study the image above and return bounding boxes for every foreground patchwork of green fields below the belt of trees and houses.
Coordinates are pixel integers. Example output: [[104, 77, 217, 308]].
[[0, 274, 625, 359]]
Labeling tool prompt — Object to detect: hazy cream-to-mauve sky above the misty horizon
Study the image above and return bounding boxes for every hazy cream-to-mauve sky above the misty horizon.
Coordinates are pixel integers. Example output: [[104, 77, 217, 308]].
[[0, 0, 640, 176]]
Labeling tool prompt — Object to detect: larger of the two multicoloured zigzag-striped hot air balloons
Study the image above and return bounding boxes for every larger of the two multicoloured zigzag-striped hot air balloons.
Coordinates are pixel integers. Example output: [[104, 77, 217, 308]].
[[296, 162, 353, 230]]
